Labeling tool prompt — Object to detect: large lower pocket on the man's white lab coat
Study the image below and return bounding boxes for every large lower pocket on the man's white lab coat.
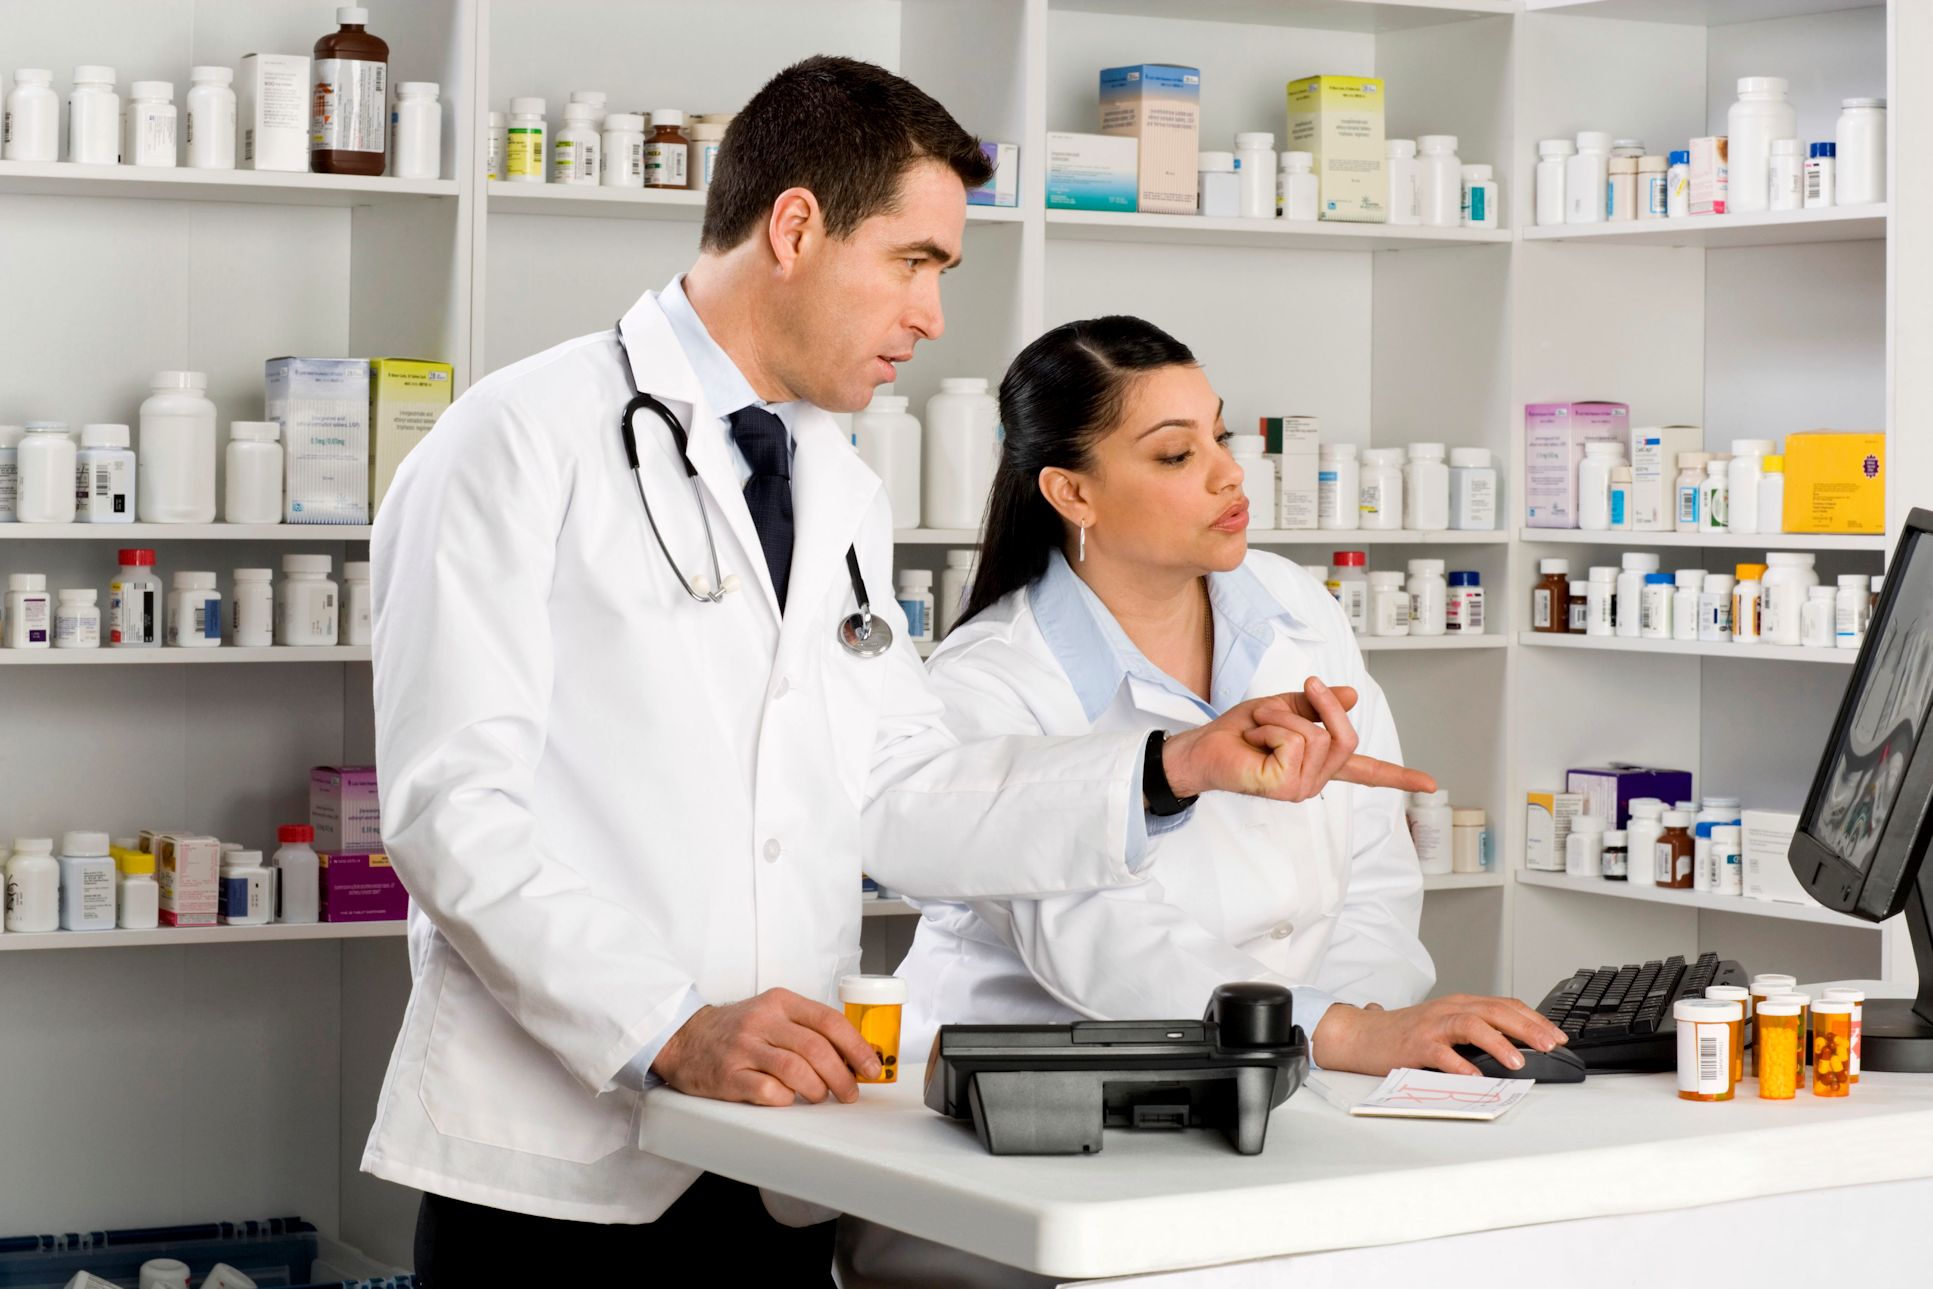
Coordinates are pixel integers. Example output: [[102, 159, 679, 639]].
[[419, 953, 638, 1163]]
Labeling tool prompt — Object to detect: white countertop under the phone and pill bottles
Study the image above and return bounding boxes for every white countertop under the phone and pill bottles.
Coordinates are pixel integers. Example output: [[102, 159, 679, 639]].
[[640, 1065, 1933, 1277]]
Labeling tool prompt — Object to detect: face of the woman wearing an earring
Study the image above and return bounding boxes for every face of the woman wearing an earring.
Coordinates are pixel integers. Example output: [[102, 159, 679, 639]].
[[1042, 367, 1244, 574]]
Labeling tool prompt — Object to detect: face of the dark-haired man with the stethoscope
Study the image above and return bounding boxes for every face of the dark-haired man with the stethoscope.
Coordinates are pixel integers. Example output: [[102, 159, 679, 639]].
[[771, 160, 967, 412]]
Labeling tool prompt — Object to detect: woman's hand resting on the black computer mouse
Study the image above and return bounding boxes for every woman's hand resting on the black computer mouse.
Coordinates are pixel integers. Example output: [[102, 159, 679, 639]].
[[1313, 993, 1566, 1074]]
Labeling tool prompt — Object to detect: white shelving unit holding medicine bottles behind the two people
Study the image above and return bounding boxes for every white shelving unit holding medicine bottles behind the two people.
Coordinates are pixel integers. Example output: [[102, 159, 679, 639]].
[[0, 0, 1933, 1264]]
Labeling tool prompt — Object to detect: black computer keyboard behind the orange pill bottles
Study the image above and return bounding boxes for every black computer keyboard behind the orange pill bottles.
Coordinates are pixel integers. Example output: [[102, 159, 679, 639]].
[[1537, 953, 1745, 1073]]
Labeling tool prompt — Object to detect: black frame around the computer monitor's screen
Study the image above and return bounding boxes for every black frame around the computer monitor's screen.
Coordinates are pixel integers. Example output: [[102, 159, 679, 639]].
[[1786, 510, 1933, 922]]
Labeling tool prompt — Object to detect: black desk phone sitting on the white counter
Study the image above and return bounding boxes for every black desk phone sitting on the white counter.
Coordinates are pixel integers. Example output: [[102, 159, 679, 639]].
[[926, 982, 1309, 1156]]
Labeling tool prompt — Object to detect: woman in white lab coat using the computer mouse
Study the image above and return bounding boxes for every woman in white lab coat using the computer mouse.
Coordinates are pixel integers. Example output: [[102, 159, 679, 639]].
[[901, 317, 1560, 1074]]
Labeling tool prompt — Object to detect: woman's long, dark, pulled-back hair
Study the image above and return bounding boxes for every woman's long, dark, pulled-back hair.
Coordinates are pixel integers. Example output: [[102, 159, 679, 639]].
[[961, 315, 1195, 622]]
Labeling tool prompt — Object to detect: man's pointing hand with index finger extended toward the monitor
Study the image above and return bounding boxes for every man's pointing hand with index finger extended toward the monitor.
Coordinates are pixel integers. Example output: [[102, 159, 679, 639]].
[[1162, 676, 1436, 802]]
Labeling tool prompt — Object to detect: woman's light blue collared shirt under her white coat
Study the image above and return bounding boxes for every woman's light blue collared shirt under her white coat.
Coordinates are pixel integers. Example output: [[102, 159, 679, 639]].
[[1028, 551, 1336, 1036]]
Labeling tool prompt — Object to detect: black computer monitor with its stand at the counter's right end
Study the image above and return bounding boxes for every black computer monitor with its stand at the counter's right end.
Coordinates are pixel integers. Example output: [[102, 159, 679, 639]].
[[1788, 510, 1933, 1073]]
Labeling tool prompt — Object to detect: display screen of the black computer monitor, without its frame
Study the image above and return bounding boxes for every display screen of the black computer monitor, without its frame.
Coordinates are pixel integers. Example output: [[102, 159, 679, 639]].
[[1802, 530, 1933, 874]]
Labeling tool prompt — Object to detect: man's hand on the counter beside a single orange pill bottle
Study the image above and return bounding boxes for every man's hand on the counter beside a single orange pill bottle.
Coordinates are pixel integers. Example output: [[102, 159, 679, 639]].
[[651, 989, 880, 1105]]
